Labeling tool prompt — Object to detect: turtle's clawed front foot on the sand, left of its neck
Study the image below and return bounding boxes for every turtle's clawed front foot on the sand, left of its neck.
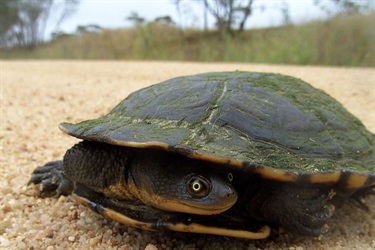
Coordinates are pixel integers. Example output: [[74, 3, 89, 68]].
[[28, 160, 73, 196]]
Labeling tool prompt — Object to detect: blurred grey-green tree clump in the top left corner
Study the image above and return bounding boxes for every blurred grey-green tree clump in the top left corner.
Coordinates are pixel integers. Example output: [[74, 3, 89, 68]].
[[0, 0, 79, 47]]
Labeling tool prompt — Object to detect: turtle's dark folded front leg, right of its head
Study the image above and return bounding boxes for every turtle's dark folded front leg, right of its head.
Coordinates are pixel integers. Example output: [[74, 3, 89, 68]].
[[242, 184, 335, 236]]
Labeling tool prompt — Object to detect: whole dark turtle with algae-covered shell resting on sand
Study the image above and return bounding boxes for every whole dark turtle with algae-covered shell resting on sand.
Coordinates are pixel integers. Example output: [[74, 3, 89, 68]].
[[29, 71, 375, 239]]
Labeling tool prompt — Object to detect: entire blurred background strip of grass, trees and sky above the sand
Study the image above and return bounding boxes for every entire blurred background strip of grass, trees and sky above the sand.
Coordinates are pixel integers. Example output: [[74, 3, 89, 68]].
[[0, 0, 375, 67]]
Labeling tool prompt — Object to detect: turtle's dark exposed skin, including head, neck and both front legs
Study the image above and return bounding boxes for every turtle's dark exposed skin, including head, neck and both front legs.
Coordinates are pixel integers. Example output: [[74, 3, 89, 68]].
[[30, 141, 340, 235]]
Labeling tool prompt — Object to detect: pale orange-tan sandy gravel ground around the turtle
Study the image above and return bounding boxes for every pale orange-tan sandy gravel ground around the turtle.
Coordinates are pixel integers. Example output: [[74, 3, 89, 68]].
[[0, 61, 375, 250]]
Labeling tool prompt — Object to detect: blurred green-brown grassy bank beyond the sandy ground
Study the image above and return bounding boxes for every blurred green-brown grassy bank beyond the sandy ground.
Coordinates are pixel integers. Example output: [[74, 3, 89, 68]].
[[0, 12, 375, 67]]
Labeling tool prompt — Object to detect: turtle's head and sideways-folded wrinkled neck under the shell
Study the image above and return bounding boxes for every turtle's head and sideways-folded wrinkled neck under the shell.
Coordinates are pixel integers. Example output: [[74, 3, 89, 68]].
[[33, 141, 237, 215]]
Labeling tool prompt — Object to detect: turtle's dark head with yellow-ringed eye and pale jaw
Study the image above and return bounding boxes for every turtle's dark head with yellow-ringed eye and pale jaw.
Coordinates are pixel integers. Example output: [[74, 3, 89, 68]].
[[128, 149, 237, 215]]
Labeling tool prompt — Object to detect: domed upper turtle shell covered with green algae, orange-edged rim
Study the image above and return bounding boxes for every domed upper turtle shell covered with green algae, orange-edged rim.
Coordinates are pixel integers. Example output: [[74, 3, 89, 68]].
[[60, 72, 375, 189]]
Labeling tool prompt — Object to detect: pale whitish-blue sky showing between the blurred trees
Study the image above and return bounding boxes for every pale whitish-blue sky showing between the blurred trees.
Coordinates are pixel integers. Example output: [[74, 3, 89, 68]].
[[46, 0, 332, 34]]
